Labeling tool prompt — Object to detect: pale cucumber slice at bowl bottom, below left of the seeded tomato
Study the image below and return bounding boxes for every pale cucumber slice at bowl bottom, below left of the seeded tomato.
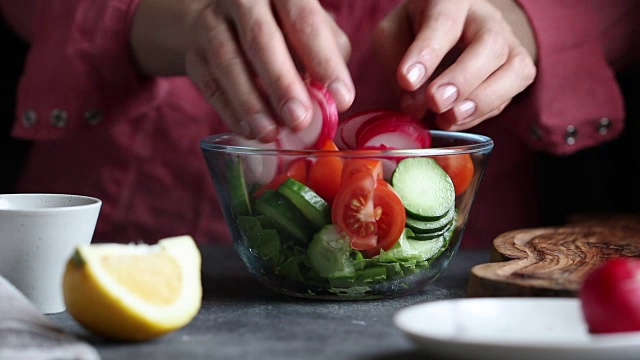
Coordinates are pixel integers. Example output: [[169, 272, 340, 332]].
[[307, 224, 356, 279]]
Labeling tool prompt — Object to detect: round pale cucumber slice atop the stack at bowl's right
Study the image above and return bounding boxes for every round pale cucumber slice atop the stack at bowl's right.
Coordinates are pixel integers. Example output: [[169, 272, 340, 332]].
[[391, 157, 456, 221]]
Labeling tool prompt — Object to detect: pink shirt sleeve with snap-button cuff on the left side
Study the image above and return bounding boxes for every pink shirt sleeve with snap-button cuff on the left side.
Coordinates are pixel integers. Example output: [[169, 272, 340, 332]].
[[0, 0, 165, 140]]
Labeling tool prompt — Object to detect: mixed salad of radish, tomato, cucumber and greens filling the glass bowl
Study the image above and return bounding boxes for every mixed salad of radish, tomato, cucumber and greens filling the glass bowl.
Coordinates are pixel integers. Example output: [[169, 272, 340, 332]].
[[228, 83, 474, 297]]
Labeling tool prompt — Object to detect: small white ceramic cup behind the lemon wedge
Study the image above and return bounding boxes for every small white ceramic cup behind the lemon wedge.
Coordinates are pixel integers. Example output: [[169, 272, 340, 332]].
[[0, 194, 102, 314]]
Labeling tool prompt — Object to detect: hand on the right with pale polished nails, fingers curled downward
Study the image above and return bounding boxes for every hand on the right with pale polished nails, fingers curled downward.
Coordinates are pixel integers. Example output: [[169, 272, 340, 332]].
[[376, 0, 536, 131]]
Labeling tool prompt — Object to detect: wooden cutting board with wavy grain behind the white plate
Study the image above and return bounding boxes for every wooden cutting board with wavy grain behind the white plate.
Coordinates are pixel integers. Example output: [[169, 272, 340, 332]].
[[467, 215, 640, 297]]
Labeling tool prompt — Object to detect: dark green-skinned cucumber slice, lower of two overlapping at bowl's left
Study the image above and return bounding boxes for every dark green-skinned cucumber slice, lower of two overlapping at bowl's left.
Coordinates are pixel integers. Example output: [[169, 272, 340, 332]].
[[256, 189, 313, 245]]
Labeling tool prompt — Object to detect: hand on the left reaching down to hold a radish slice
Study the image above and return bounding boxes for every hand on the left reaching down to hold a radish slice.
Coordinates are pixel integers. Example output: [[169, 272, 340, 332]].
[[185, 0, 355, 142]]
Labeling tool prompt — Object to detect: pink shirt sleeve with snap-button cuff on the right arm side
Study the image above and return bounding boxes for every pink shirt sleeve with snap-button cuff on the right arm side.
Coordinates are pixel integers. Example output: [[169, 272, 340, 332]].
[[508, 0, 625, 155]]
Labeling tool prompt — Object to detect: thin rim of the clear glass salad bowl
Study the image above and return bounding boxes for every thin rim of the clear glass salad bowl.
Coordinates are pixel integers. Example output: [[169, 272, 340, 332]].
[[200, 130, 494, 157]]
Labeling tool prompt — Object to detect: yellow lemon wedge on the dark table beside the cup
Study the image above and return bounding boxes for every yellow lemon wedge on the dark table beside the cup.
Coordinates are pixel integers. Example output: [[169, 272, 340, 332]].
[[62, 236, 202, 341]]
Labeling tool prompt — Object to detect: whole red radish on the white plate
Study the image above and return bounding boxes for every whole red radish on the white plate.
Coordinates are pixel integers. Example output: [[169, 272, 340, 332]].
[[580, 257, 640, 334]]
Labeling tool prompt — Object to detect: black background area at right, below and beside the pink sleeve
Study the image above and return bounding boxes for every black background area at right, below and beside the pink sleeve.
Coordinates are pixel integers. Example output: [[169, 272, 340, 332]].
[[538, 71, 640, 225]]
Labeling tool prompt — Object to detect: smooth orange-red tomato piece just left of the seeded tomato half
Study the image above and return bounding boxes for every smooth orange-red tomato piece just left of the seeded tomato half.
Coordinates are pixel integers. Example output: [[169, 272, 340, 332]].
[[307, 140, 343, 204]]
